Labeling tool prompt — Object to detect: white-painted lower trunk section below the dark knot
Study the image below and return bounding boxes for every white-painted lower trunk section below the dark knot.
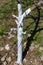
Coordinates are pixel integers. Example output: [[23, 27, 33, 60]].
[[17, 24, 23, 63]]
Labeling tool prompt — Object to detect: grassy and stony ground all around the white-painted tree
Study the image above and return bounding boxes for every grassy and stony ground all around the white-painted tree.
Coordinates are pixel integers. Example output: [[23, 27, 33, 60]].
[[0, 0, 43, 65]]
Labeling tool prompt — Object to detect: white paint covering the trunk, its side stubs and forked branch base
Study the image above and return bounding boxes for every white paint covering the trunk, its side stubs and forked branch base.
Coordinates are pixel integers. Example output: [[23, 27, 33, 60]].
[[13, 3, 31, 64]]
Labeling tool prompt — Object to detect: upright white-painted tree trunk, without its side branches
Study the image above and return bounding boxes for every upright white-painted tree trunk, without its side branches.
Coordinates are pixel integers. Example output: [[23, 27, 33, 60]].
[[17, 3, 23, 64]]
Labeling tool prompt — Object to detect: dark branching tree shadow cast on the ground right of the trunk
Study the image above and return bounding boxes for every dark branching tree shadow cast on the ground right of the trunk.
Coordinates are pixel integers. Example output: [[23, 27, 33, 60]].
[[23, 7, 43, 59]]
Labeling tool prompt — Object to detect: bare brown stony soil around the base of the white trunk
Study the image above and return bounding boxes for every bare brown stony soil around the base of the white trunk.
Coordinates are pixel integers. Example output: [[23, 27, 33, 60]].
[[0, 40, 43, 65]]
